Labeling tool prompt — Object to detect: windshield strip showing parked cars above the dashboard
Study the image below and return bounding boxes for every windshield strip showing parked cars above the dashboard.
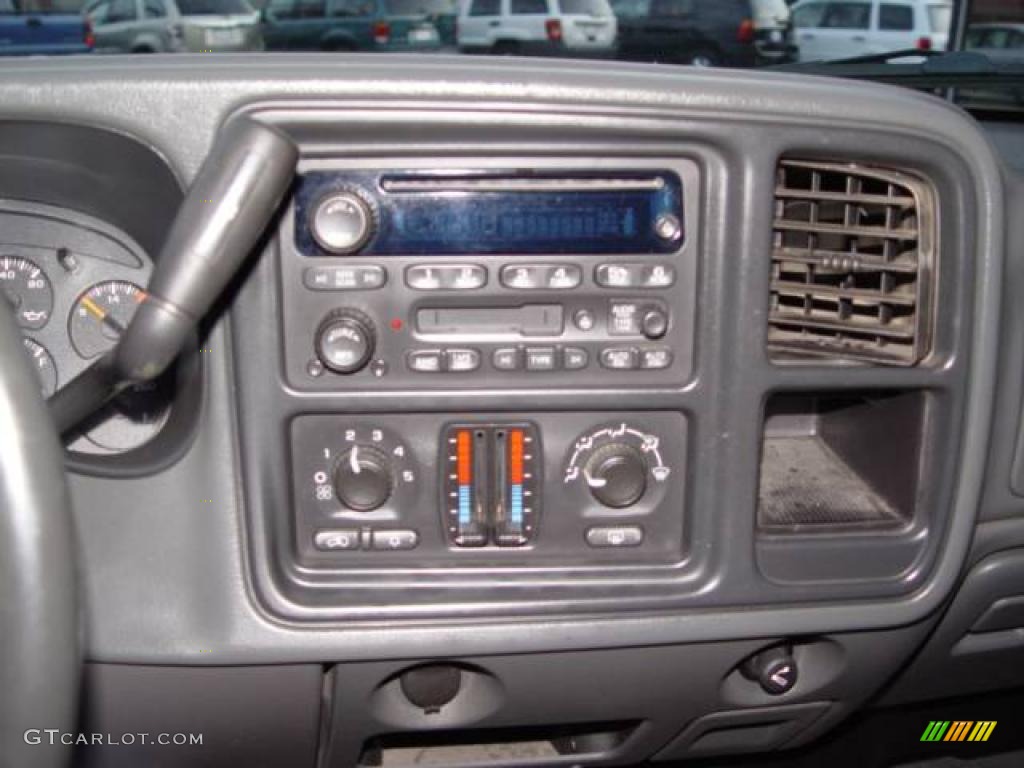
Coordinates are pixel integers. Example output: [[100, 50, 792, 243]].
[[0, 0, 1024, 115]]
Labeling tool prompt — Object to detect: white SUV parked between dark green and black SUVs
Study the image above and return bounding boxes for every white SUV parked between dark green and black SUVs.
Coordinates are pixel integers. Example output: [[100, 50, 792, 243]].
[[459, 0, 618, 58]]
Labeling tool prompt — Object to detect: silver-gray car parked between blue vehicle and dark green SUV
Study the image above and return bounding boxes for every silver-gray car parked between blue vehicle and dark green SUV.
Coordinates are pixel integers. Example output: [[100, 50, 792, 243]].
[[85, 0, 263, 53]]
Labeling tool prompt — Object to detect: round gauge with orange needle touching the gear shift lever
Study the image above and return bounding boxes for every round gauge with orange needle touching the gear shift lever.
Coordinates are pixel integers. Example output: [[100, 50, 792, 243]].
[[68, 280, 146, 359]]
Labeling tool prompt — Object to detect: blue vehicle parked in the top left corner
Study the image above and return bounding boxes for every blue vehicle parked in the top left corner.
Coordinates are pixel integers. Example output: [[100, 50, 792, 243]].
[[0, 0, 93, 55]]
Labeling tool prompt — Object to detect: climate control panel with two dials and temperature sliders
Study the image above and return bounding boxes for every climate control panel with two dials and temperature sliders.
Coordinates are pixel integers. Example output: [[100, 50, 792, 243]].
[[291, 412, 687, 568]]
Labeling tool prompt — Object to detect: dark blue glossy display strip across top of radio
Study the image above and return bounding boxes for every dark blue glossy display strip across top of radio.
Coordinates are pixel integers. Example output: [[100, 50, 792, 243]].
[[296, 171, 683, 256]]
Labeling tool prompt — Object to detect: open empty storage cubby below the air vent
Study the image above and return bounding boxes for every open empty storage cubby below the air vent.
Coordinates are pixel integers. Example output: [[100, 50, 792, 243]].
[[758, 390, 926, 534]]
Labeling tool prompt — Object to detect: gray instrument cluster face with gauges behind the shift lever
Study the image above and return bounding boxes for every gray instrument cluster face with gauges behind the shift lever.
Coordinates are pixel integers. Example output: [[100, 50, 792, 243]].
[[0, 201, 173, 455]]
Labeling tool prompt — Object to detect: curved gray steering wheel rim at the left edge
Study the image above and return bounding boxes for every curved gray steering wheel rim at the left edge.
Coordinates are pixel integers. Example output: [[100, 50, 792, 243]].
[[0, 298, 81, 768]]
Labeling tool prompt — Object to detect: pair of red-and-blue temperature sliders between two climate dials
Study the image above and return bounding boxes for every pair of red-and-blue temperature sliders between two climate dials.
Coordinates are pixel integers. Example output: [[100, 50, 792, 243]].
[[441, 424, 541, 547]]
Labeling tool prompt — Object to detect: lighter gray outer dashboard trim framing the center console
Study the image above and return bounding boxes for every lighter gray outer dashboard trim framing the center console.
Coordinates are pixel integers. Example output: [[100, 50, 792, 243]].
[[0, 54, 1004, 665]]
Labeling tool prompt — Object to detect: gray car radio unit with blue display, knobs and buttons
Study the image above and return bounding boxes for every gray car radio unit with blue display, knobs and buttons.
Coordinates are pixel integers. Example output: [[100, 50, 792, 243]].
[[280, 158, 700, 392]]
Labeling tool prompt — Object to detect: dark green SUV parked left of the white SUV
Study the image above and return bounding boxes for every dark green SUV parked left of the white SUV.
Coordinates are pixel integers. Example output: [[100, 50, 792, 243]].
[[263, 0, 456, 51]]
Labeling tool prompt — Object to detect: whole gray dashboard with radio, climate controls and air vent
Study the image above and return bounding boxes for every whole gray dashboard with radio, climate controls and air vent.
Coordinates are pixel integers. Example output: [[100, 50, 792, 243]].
[[0, 54, 1024, 768]]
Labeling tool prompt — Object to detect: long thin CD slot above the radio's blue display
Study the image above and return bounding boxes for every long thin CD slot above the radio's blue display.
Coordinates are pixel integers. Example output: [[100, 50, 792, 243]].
[[381, 176, 665, 194]]
